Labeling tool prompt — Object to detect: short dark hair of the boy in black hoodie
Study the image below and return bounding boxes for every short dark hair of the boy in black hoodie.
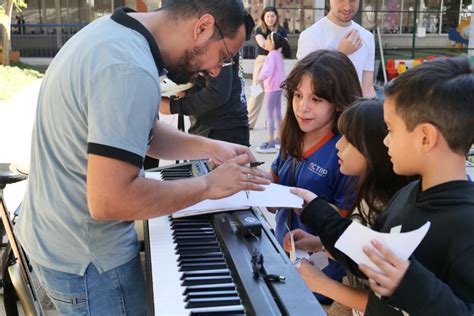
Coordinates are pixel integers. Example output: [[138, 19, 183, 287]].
[[384, 56, 474, 155]]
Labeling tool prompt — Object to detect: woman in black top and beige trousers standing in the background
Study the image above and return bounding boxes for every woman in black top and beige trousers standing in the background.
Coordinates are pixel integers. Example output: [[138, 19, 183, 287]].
[[247, 6, 289, 129]]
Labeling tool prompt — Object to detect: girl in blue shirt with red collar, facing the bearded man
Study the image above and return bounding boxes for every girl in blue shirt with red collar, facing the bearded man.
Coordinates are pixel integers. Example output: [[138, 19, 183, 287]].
[[264, 50, 362, 303]]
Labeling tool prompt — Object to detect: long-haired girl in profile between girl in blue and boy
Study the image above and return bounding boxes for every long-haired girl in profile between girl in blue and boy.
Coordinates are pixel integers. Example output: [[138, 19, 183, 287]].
[[284, 99, 410, 315]]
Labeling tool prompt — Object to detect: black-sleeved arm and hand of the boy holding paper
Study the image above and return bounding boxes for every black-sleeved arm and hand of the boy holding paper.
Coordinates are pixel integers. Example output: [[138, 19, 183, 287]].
[[360, 242, 474, 315]]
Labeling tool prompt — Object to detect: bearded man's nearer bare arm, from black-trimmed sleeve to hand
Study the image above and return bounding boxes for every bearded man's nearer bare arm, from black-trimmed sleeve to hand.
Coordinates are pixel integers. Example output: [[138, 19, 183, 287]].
[[87, 154, 269, 220]]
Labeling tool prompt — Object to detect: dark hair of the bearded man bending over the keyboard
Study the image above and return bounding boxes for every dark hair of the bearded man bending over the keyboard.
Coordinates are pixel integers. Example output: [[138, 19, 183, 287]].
[[161, 0, 255, 40]]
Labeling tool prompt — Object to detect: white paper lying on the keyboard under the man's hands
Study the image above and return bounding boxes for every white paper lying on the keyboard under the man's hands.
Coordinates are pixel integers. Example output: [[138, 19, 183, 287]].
[[173, 183, 303, 218]]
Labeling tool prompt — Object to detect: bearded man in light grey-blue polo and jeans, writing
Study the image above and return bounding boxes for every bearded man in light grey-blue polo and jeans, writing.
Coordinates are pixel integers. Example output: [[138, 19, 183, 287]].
[[16, 0, 262, 315]]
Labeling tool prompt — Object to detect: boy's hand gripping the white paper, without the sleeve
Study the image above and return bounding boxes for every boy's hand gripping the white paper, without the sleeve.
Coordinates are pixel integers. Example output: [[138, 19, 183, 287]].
[[359, 240, 410, 297]]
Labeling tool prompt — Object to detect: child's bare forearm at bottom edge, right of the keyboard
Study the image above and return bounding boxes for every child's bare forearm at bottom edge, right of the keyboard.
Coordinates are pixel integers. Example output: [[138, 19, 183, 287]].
[[298, 260, 368, 312]]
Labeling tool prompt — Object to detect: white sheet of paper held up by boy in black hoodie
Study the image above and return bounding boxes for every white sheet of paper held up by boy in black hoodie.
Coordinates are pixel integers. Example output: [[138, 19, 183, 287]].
[[335, 222, 431, 273]]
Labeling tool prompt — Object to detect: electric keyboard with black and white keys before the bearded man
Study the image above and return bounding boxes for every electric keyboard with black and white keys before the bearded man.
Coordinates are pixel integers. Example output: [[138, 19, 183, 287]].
[[144, 161, 325, 315]]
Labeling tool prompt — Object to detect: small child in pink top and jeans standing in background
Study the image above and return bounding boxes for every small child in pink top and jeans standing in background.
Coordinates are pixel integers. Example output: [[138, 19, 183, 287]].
[[257, 32, 290, 153]]
